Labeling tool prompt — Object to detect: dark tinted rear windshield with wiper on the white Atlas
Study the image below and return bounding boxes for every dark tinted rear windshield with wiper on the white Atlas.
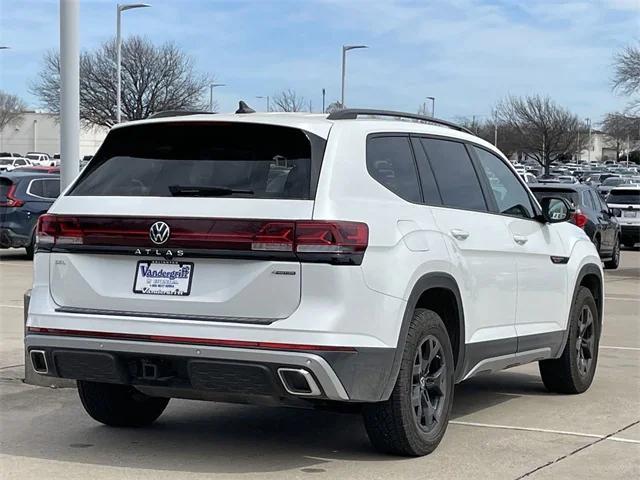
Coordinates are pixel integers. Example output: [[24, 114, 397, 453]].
[[70, 122, 325, 199]]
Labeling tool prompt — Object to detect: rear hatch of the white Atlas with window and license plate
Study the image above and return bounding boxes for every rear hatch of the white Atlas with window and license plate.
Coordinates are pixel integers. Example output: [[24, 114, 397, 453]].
[[38, 121, 328, 323]]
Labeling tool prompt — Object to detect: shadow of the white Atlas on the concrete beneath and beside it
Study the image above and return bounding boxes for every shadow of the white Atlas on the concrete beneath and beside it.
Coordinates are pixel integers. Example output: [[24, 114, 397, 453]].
[[0, 372, 545, 474]]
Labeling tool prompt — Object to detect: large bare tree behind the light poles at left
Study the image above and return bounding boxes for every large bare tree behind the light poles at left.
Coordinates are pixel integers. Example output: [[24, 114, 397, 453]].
[[31, 37, 213, 127]]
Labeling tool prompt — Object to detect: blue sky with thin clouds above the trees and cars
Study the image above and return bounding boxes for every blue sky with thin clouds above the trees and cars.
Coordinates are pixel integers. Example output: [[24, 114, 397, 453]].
[[0, 0, 640, 121]]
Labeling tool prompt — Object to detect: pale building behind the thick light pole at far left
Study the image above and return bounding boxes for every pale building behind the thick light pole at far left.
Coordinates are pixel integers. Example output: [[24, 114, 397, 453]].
[[0, 112, 108, 157]]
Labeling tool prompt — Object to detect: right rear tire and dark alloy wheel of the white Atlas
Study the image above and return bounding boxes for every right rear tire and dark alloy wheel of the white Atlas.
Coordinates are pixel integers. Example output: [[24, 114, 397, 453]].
[[363, 308, 455, 456]]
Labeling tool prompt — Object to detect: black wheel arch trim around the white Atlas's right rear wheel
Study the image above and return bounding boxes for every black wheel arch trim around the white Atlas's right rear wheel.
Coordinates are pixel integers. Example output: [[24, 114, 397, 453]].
[[381, 272, 465, 400]]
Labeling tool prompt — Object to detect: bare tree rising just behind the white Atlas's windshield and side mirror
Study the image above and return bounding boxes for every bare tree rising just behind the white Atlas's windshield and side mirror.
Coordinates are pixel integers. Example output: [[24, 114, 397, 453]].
[[496, 95, 581, 173]]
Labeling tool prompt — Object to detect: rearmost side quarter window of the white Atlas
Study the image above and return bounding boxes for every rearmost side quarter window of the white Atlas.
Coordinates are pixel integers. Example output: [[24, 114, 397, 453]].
[[367, 136, 422, 203]]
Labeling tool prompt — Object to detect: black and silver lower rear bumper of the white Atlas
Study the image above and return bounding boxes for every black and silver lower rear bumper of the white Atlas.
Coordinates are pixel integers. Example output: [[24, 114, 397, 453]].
[[25, 334, 394, 404]]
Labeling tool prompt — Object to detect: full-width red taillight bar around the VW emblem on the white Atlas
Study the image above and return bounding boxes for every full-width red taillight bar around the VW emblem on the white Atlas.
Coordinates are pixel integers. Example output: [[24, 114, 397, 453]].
[[37, 214, 369, 265]]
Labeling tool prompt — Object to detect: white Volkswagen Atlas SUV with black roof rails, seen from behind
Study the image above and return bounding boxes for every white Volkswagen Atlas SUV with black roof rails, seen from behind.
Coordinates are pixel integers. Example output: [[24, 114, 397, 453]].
[[26, 108, 604, 455]]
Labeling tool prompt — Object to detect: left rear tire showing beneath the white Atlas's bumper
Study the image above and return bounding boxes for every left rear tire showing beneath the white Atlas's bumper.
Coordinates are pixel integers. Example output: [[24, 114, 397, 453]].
[[78, 380, 169, 427]]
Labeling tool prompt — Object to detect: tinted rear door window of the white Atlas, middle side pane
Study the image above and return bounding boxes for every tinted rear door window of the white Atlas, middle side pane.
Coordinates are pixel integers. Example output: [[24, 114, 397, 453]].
[[420, 138, 487, 211]]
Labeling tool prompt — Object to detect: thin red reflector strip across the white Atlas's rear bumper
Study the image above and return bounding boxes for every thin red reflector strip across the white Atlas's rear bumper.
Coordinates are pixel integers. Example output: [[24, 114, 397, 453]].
[[27, 327, 356, 352]]
